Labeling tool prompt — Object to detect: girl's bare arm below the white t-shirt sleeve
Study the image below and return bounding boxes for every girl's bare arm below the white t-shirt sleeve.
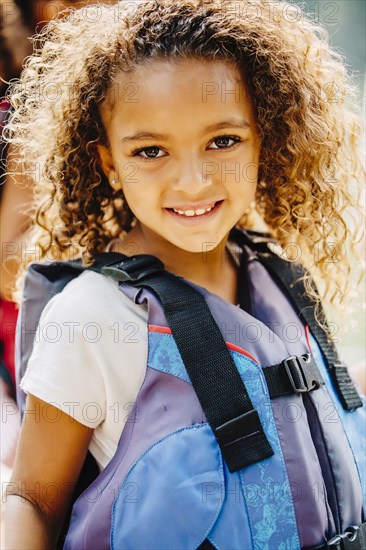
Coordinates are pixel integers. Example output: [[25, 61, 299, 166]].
[[2, 394, 93, 550]]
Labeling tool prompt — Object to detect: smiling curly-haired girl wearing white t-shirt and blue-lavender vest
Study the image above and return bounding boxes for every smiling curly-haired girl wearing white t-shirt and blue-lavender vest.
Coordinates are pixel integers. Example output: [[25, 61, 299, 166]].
[[5, 0, 364, 549]]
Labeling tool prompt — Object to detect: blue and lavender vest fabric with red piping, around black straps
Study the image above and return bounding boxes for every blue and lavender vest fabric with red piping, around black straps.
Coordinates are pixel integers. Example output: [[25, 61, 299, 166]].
[[15, 232, 366, 550]]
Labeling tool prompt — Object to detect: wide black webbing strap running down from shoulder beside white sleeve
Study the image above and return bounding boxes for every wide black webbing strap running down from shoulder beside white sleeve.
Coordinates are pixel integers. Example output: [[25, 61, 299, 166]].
[[101, 262, 273, 472]]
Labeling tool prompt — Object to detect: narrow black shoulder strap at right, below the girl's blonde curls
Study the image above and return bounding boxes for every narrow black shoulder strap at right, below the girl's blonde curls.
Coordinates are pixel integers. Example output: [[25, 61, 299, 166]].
[[230, 229, 362, 410]]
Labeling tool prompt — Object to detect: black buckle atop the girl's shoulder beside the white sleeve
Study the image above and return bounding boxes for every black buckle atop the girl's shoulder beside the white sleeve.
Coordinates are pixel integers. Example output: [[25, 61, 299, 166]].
[[101, 254, 164, 282]]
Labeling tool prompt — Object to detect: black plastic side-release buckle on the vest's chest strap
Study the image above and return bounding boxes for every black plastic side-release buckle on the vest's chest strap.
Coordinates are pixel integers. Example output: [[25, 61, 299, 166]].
[[282, 353, 323, 393]]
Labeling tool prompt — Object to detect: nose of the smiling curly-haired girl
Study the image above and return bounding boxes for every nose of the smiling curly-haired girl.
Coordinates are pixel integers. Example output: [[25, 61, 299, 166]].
[[172, 155, 216, 195]]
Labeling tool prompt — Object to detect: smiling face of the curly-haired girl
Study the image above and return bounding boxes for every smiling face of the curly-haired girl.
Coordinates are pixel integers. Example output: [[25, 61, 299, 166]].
[[98, 60, 260, 252]]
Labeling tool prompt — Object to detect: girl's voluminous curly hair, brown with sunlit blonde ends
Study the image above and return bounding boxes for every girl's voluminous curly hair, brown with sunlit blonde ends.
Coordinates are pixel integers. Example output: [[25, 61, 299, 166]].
[[3, 0, 364, 314]]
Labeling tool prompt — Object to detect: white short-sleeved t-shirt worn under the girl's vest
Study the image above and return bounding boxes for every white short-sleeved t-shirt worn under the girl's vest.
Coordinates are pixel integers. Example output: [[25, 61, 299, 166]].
[[20, 271, 147, 470]]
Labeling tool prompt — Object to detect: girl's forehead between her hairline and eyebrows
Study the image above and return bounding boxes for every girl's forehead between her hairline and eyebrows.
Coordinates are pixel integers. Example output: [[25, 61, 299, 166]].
[[102, 59, 252, 130]]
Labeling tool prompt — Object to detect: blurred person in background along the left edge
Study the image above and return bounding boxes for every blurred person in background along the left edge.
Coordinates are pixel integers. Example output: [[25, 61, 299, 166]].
[[0, 0, 115, 468]]
